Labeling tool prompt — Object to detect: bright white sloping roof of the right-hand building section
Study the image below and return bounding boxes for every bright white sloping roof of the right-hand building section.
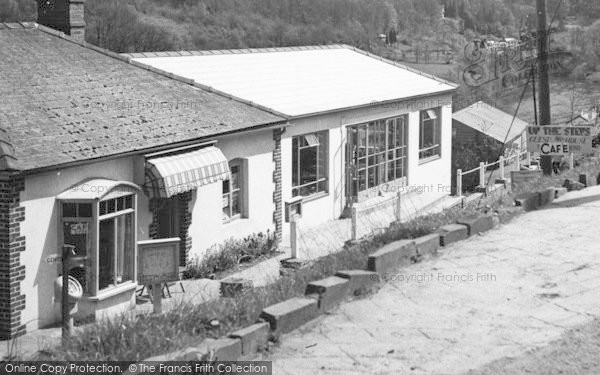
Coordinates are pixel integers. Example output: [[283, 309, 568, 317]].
[[126, 45, 456, 117]]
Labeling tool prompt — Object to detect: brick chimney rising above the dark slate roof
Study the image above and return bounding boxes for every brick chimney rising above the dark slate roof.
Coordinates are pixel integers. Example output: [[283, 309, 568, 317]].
[[38, 0, 85, 42]]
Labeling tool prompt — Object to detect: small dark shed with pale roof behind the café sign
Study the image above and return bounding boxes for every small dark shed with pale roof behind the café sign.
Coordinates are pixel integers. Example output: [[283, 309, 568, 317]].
[[452, 101, 527, 152]]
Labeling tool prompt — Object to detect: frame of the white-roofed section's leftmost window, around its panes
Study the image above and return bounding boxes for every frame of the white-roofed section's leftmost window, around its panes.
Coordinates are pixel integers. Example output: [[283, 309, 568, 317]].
[[292, 130, 329, 199]]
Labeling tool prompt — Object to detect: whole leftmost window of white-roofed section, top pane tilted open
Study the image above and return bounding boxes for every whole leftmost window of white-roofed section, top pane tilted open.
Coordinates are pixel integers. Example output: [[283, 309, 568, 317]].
[[292, 131, 329, 197]]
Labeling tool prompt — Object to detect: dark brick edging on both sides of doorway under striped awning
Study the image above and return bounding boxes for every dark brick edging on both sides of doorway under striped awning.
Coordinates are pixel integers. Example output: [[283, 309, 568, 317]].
[[148, 191, 192, 266]]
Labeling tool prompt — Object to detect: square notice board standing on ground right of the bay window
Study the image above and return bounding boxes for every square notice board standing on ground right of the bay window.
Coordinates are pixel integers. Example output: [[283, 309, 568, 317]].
[[137, 238, 181, 285]]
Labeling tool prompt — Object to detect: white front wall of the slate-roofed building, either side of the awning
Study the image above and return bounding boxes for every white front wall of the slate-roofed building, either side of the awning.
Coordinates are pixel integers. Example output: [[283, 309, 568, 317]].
[[11, 129, 281, 339]]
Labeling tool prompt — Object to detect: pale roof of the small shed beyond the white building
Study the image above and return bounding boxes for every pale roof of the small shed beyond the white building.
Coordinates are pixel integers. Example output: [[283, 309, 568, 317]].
[[452, 102, 528, 143]]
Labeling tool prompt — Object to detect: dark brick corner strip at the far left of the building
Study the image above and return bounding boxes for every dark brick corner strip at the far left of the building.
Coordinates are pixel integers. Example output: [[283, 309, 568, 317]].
[[0, 173, 26, 340]]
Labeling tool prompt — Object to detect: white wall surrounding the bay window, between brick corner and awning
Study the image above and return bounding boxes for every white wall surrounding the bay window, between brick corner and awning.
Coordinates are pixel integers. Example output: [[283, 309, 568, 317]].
[[21, 157, 150, 330]]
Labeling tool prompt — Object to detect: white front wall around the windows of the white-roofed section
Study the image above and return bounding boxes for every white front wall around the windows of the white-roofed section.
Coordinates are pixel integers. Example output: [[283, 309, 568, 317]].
[[281, 95, 452, 236]]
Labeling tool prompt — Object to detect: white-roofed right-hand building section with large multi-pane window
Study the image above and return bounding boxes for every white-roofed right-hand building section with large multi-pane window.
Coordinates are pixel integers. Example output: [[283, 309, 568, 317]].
[[126, 45, 456, 233]]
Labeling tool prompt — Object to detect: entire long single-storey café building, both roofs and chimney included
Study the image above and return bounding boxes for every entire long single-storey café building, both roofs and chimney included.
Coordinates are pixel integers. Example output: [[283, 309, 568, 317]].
[[0, 0, 455, 339]]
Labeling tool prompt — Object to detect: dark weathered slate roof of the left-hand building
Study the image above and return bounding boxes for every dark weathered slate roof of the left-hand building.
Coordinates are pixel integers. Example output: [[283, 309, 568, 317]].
[[0, 23, 286, 170]]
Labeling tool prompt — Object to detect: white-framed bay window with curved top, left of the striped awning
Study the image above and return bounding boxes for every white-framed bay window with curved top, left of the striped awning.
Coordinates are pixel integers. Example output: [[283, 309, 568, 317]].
[[57, 179, 140, 301]]
